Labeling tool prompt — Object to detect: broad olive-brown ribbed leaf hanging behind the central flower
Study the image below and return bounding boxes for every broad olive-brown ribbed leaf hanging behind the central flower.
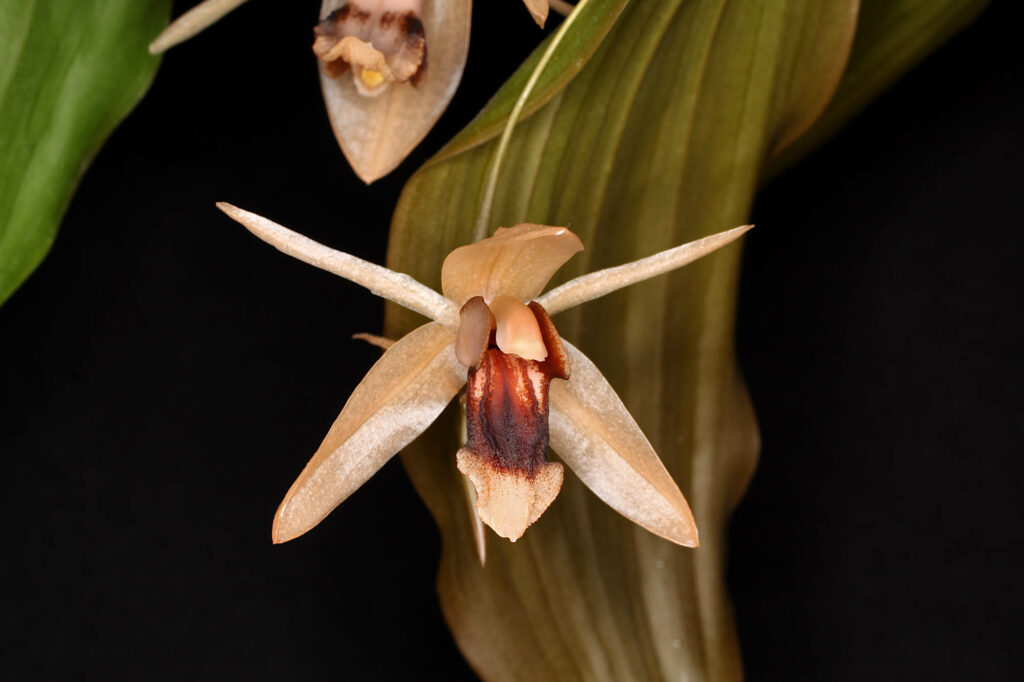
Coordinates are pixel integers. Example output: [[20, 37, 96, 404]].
[[388, 0, 857, 680]]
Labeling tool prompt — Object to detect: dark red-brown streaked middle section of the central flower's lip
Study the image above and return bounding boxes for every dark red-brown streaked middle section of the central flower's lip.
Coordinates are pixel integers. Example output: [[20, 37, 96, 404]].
[[465, 348, 551, 477]]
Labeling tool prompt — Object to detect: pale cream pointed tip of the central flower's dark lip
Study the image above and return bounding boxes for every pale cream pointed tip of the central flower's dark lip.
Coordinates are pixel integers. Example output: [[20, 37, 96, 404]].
[[456, 447, 563, 542]]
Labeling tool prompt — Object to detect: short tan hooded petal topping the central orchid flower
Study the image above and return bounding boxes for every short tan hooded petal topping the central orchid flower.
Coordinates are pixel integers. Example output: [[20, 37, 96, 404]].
[[441, 223, 583, 307]]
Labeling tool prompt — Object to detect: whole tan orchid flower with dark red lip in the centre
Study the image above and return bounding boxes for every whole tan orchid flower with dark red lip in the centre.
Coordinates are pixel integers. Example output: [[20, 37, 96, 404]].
[[217, 199, 751, 560]]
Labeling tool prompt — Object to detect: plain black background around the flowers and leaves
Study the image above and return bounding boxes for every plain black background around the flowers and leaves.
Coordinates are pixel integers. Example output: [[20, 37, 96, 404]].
[[0, 1, 1024, 681]]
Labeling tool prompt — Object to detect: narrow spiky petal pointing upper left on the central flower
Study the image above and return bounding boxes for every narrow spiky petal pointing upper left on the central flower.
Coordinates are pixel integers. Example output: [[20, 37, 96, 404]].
[[217, 202, 459, 329]]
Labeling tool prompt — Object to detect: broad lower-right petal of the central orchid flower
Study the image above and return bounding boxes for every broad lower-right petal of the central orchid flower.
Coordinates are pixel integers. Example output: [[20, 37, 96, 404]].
[[549, 339, 698, 547]]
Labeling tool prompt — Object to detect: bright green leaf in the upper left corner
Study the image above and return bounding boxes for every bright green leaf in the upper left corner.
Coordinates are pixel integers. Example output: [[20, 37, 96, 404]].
[[0, 0, 170, 303]]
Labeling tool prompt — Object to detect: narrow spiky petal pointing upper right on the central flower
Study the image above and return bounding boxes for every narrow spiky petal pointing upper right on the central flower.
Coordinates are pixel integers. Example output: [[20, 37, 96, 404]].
[[537, 225, 754, 314]]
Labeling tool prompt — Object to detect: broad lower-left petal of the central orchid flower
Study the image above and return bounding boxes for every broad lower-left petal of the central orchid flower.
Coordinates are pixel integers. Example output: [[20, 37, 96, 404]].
[[273, 323, 466, 543]]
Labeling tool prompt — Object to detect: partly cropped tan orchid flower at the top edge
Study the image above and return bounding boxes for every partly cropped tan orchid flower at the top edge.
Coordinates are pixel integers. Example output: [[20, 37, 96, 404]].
[[150, 0, 571, 184]]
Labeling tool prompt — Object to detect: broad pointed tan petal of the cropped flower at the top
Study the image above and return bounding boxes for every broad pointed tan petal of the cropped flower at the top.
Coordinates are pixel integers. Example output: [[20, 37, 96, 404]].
[[319, 0, 472, 184]]
